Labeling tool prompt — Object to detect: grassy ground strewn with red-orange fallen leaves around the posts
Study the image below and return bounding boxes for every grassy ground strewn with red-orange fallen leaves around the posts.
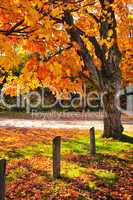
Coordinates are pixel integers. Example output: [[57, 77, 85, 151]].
[[0, 128, 133, 200]]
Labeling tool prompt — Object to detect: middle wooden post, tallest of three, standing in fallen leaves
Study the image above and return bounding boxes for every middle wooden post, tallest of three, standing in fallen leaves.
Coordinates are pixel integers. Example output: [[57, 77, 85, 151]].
[[53, 136, 61, 178]]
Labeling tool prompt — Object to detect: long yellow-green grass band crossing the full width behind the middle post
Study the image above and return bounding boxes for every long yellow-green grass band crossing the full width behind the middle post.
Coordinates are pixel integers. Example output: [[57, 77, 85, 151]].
[[0, 131, 133, 161]]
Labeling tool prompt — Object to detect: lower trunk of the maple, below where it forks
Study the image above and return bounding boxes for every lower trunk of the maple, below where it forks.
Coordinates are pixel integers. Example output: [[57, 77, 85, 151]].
[[103, 88, 123, 139]]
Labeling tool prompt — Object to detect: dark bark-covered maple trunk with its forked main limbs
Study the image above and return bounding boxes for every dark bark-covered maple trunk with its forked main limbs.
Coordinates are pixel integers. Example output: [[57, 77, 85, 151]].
[[64, 5, 123, 138]]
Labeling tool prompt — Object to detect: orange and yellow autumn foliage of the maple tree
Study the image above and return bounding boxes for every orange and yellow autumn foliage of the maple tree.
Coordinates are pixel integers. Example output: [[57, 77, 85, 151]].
[[0, 0, 133, 95]]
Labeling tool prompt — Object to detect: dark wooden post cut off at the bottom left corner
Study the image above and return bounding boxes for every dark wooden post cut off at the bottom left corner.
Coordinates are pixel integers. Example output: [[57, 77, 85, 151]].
[[0, 159, 6, 200]]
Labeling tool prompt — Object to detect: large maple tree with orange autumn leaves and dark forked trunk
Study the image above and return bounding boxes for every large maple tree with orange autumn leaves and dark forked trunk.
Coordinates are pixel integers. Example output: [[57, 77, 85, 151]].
[[0, 0, 133, 137]]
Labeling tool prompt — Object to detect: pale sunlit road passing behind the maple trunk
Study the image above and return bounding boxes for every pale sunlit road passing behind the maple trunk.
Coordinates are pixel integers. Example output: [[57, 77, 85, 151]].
[[0, 119, 133, 132]]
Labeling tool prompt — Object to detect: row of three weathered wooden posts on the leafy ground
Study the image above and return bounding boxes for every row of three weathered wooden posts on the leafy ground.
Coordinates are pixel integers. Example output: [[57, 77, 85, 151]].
[[0, 128, 96, 200]]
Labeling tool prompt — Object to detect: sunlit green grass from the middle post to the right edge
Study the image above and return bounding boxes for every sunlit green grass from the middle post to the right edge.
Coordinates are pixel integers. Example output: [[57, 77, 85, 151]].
[[61, 131, 133, 158]]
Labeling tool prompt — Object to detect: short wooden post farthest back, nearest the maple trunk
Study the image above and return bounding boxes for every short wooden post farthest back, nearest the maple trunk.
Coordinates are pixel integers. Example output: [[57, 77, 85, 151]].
[[90, 127, 96, 156]]
